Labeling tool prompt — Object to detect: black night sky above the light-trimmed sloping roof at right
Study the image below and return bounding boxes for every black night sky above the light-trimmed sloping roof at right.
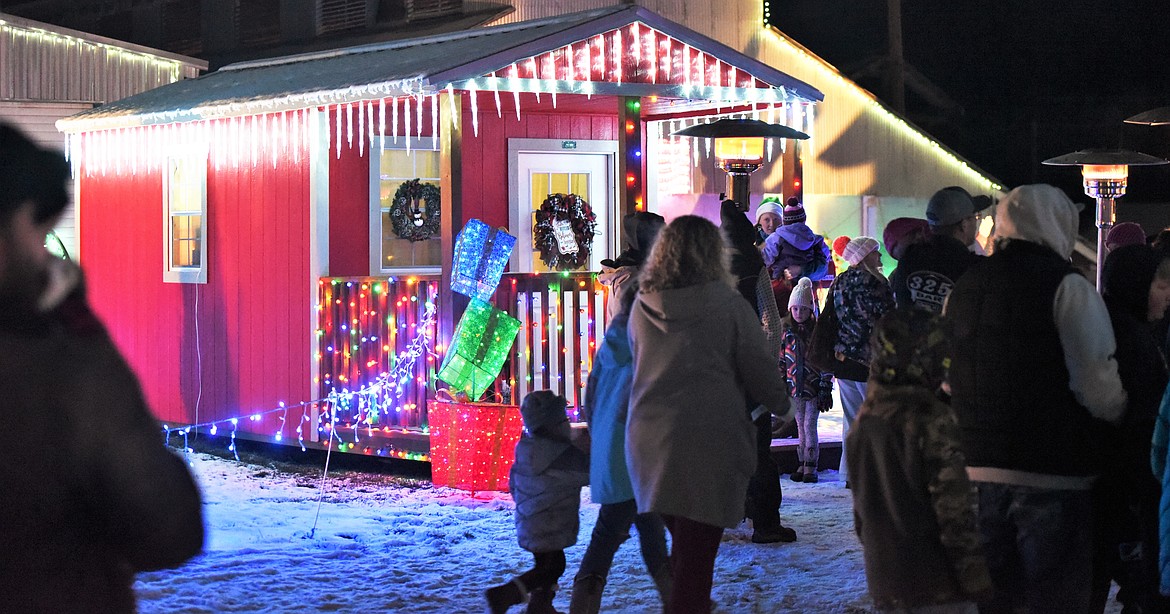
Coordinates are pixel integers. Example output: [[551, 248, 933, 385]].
[[771, 0, 1170, 202]]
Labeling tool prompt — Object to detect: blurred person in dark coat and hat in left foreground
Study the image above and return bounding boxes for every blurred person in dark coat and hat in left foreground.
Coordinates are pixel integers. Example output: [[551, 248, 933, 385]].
[[0, 125, 204, 613]]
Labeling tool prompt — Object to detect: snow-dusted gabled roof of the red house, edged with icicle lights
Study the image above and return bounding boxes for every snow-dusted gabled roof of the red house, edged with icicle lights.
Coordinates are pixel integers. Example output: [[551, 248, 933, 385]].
[[57, 6, 824, 132]]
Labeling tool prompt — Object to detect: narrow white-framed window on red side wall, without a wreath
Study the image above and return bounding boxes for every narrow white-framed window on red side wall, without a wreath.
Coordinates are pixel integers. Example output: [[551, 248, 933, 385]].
[[163, 149, 207, 283]]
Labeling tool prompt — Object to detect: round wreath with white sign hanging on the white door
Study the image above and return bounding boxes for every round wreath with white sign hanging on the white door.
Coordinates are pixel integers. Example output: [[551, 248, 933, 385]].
[[532, 194, 597, 270]]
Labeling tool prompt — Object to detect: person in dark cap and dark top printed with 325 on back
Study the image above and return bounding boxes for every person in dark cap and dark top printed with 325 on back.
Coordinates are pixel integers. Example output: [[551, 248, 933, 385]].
[[886, 186, 991, 313]]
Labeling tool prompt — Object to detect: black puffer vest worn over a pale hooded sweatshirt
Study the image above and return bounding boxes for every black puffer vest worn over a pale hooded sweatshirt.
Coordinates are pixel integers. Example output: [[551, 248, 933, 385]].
[[947, 240, 1100, 476]]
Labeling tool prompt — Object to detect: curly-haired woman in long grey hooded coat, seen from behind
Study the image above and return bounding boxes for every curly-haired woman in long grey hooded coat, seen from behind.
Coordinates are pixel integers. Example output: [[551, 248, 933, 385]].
[[626, 215, 791, 613]]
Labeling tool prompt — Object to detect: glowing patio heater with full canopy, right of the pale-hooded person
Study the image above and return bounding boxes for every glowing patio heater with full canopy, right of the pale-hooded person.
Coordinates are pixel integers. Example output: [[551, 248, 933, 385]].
[[1042, 150, 1166, 292]]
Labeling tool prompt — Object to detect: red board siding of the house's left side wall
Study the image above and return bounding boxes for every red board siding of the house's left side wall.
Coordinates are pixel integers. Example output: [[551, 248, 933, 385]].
[[80, 113, 315, 437]]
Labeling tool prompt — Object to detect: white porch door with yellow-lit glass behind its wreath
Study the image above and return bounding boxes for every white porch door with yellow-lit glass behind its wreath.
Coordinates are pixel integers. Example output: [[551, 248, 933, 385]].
[[511, 151, 618, 272]]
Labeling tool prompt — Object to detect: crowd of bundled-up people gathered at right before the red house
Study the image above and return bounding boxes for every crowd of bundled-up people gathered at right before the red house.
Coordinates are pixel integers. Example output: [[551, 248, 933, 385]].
[[488, 185, 1170, 614]]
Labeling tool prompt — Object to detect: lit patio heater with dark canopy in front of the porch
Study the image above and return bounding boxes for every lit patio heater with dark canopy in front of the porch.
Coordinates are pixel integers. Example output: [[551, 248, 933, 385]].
[[674, 118, 808, 212]]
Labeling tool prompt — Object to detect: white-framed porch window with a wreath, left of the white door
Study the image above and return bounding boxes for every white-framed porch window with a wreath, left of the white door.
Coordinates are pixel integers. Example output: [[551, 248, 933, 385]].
[[370, 137, 442, 275]]
